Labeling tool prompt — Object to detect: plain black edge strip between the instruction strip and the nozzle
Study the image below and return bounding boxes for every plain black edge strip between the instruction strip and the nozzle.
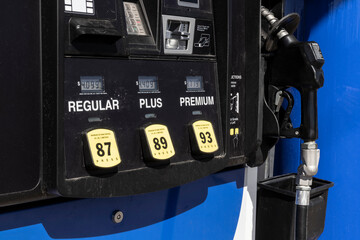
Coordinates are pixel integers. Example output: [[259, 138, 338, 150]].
[[244, 1, 264, 167]]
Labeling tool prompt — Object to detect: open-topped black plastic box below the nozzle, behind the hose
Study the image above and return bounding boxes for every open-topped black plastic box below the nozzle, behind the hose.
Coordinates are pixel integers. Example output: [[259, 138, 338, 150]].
[[256, 174, 334, 240]]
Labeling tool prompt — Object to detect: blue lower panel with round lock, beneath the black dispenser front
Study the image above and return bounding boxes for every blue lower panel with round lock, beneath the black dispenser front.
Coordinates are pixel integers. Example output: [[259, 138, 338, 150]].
[[0, 169, 244, 240]]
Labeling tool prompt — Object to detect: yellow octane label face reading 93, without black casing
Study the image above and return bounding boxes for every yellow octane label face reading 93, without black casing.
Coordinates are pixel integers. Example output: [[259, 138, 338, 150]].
[[192, 120, 219, 153]]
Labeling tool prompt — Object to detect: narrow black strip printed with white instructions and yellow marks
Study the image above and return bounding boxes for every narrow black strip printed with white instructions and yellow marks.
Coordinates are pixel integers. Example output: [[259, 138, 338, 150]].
[[227, 1, 246, 158]]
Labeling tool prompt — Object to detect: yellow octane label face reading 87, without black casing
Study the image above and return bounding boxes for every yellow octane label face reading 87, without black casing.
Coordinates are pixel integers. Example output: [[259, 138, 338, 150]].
[[86, 129, 121, 168]]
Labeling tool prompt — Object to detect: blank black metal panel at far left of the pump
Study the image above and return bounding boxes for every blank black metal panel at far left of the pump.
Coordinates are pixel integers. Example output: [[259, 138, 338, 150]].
[[0, 0, 42, 204]]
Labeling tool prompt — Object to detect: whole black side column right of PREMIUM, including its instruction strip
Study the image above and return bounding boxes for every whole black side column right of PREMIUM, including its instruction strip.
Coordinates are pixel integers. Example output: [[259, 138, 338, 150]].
[[214, 0, 263, 166]]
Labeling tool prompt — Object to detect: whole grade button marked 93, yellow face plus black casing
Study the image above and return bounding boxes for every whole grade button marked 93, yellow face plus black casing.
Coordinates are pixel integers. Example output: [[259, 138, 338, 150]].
[[190, 120, 219, 158]]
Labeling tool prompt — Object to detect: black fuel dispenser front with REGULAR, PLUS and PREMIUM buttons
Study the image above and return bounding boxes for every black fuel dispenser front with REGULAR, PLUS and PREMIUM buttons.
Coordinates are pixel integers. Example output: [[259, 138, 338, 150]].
[[0, 0, 263, 206]]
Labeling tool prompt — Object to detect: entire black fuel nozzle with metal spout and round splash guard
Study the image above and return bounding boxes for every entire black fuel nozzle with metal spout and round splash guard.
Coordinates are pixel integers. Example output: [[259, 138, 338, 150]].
[[261, 7, 325, 142]]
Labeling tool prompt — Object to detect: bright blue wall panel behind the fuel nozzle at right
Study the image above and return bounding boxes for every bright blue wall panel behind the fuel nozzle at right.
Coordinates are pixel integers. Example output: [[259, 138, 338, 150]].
[[281, 0, 360, 240]]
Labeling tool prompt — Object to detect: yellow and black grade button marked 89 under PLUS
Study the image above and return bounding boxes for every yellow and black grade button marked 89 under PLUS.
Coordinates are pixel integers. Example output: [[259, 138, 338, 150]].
[[141, 124, 175, 165]]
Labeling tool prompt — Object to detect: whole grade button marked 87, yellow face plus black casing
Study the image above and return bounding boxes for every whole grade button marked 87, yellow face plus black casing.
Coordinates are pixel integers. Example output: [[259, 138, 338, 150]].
[[84, 129, 121, 172]]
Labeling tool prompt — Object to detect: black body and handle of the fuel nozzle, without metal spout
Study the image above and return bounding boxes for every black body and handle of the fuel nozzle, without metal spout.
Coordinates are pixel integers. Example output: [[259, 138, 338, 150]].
[[269, 42, 324, 141]]
